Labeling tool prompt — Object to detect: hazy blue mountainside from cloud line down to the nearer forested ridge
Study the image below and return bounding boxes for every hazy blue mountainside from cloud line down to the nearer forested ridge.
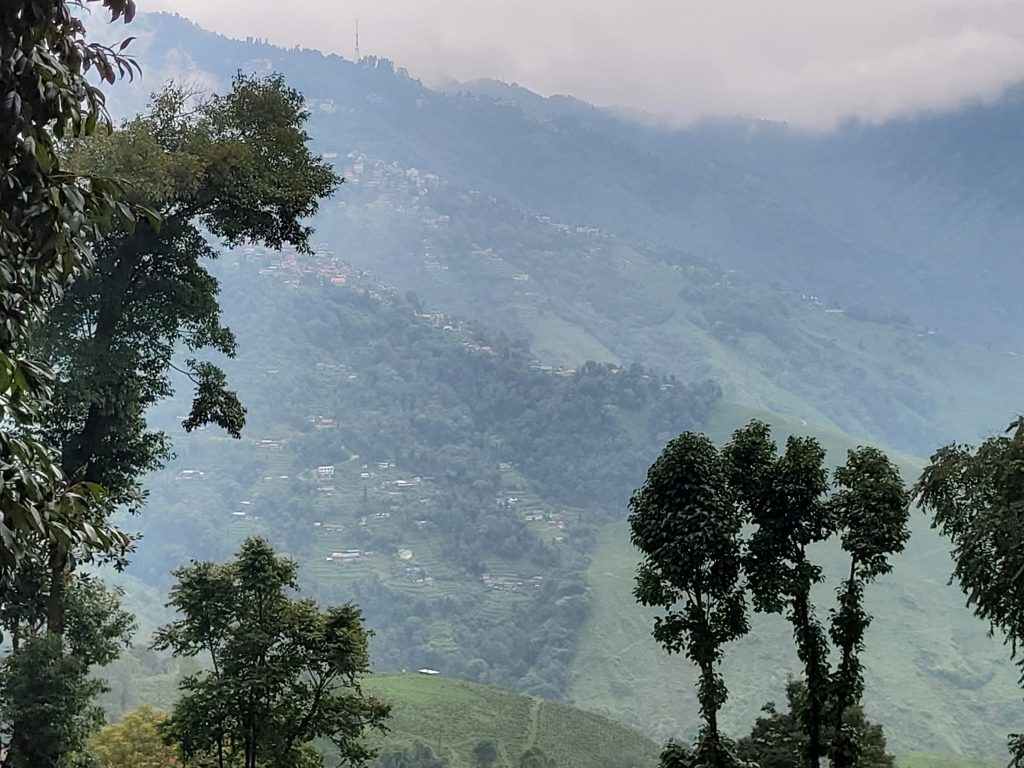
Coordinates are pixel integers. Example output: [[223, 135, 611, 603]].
[[108, 15, 1024, 455]]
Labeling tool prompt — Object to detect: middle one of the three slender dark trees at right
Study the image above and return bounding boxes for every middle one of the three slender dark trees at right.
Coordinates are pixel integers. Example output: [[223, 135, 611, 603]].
[[723, 421, 833, 768]]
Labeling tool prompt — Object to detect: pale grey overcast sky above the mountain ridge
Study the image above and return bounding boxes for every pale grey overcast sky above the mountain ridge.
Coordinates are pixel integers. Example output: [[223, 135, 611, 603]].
[[146, 0, 1024, 128]]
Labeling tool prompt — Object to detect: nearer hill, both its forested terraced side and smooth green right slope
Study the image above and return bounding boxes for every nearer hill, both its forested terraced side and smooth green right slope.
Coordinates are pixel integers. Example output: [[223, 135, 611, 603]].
[[99, 251, 1017, 754]]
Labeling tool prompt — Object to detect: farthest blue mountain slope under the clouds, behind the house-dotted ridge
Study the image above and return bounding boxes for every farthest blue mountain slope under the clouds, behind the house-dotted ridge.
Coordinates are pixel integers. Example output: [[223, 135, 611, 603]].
[[119, 15, 1024, 351]]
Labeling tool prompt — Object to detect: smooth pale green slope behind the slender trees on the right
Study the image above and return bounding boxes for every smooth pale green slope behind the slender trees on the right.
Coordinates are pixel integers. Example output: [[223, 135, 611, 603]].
[[569, 404, 1024, 758]]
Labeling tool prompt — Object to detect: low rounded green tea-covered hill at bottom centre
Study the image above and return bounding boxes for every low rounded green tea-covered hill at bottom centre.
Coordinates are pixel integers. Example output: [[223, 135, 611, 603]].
[[366, 675, 658, 768]]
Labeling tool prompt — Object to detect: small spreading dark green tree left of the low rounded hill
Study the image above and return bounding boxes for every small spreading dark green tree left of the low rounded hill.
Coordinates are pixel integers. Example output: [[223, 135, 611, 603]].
[[154, 539, 389, 768]]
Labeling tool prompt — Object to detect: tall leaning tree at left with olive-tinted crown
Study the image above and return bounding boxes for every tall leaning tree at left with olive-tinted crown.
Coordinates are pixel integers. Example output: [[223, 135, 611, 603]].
[[37, 75, 339, 634]]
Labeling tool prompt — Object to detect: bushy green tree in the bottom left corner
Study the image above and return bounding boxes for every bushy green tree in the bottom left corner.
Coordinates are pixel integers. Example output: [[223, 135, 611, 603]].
[[0, 569, 134, 768]]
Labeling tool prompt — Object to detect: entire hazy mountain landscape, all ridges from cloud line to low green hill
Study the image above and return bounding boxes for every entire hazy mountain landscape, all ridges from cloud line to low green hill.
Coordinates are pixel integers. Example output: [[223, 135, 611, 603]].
[[94, 10, 1024, 757]]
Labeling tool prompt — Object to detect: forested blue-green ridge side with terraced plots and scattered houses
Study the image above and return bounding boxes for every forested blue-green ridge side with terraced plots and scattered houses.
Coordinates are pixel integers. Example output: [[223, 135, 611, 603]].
[[126, 253, 719, 697]]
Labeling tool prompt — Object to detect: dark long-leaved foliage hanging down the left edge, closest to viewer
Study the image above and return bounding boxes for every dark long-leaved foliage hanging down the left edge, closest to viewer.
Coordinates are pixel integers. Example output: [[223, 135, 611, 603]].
[[0, 0, 135, 577]]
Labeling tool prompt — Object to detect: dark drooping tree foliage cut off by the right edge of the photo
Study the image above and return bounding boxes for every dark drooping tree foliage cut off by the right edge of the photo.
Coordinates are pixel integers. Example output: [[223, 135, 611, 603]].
[[913, 418, 1024, 766]]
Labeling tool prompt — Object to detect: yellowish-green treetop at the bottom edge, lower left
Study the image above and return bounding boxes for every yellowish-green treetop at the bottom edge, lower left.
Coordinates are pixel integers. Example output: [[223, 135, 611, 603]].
[[87, 706, 180, 768]]
